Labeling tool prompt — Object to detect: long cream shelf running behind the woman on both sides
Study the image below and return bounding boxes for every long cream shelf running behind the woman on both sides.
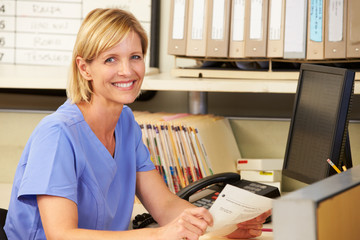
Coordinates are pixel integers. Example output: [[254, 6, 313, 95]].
[[0, 65, 360, 94]]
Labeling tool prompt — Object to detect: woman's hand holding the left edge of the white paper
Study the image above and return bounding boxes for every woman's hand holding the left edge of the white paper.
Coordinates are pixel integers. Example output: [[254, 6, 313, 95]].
[[159, 207, 213, 240]]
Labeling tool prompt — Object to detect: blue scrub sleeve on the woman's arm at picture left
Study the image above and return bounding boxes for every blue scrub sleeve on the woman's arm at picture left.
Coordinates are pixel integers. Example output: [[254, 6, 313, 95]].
[[18, 124, 77, 203]]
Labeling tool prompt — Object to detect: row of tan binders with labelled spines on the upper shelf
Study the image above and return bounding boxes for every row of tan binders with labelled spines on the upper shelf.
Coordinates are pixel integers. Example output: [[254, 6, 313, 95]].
[[168, 0, 360, 60]]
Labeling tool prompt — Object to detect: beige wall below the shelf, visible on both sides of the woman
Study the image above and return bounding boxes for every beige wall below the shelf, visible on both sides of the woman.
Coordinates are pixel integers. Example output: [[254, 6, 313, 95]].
[[0, 111, 360, 191]]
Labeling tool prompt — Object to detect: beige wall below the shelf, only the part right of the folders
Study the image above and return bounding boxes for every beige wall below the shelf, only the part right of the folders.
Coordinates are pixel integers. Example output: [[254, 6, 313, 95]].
[[231, 119, 360, 192]]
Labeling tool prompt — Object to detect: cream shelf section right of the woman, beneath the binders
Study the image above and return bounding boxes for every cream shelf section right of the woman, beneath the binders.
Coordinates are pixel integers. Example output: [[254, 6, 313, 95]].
[[142, 72, 360, 94]]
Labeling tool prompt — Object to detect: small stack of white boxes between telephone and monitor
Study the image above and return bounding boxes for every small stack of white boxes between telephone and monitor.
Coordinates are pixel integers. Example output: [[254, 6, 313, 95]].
[[237, 158, 284, 191]]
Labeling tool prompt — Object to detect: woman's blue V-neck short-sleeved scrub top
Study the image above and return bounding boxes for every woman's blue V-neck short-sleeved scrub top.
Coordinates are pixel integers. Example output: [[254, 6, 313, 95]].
[[4, 101, 155, 240]]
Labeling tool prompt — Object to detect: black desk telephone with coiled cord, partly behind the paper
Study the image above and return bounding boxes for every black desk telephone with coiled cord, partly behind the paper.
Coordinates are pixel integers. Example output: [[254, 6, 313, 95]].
[[133, 172, 280, 229]]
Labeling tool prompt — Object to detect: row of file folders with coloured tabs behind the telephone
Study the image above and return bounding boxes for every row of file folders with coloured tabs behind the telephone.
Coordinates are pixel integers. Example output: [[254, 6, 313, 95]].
[[134, 112, 240, 193]]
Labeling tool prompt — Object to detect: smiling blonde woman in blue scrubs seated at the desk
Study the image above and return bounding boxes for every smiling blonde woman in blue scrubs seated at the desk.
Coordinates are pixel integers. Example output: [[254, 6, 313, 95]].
[[4, 9, 269, 240]]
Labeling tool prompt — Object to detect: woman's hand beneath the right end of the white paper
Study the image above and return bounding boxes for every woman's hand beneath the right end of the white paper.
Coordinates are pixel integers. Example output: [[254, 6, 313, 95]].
[[226, 210, 271, 238]]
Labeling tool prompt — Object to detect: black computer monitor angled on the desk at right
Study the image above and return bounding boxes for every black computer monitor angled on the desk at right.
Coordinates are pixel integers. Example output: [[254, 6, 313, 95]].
[[283, 64, 355, 184]]
